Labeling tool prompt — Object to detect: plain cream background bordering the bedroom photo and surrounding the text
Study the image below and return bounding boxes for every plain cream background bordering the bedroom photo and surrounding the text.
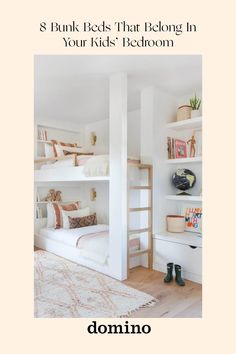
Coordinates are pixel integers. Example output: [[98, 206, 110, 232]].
[[0, 0, 236, 354]]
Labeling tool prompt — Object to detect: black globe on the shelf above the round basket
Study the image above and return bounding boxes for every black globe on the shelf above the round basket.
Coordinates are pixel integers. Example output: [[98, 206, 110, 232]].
[[172, 168, 196, 195]]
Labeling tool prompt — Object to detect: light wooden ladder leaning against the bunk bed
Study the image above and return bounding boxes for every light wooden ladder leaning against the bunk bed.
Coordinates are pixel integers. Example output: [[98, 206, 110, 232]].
[[127, 162, 153, 275]]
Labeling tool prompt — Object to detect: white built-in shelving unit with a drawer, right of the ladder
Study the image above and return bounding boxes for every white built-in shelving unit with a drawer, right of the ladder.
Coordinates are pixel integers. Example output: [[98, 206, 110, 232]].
[[153, 92, 202, 283]]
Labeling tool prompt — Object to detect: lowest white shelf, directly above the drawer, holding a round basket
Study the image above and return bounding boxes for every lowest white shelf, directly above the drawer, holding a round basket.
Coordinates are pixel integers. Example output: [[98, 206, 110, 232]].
[[153, 231, 202, 247]]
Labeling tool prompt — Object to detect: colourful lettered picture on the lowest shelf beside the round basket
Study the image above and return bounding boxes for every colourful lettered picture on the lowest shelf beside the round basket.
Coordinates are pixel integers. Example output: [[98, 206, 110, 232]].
[[181, 205, 202, 233]]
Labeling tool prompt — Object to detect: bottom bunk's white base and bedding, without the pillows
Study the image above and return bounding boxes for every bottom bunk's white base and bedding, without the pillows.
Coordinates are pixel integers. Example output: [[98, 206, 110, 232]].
[[35, 224, 140, 275]]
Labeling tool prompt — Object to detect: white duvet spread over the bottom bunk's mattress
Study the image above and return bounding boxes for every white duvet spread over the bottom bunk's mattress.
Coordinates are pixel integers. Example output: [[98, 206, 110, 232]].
[[40, 224, 109, 264]]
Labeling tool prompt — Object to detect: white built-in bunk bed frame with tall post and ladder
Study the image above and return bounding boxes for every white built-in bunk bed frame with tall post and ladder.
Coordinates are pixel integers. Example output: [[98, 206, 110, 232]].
[[35, 73, 152, 280]]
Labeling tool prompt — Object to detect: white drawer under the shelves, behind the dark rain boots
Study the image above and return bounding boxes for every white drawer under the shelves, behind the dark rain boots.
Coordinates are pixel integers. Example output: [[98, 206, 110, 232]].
[[154, 239, 202, 282]]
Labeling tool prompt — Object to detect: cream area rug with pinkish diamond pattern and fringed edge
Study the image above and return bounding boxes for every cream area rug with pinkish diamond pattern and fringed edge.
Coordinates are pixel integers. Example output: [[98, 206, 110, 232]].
[[34, 251, 158, 318]]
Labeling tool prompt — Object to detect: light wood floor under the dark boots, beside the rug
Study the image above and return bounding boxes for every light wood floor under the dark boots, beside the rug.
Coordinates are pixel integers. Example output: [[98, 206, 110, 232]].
[[35, 248, 202, 318]]
